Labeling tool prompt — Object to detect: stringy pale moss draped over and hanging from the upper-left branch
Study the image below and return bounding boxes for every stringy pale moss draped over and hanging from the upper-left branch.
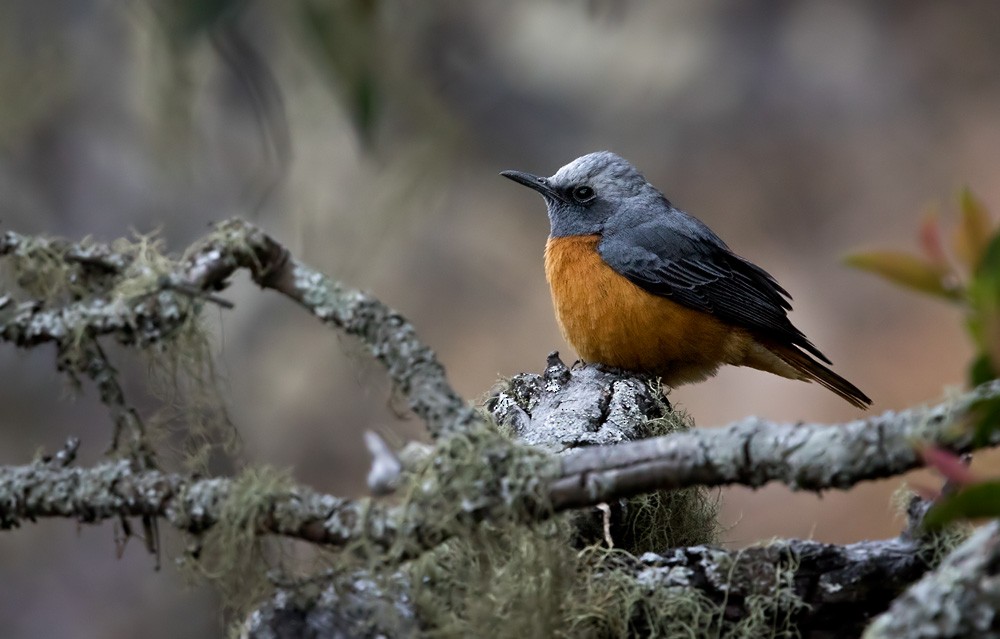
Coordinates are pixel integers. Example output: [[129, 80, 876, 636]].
[[3, 233, 238, 471]]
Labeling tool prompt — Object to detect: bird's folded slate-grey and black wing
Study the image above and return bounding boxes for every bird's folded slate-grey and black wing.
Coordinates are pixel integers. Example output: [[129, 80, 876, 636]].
[[598, 215, 830, 363]]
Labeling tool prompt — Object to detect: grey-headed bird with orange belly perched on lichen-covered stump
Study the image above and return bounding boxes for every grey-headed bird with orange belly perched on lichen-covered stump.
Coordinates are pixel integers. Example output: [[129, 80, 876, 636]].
[[500, 151, 872, 409]]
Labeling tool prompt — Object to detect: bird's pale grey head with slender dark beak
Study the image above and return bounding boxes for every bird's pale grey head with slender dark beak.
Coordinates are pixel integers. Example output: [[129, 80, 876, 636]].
[[500, 151, 674, 237]]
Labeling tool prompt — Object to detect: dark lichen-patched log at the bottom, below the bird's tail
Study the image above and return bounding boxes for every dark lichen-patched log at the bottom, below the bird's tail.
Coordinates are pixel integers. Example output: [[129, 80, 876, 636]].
[[592, 538, 928, 639]]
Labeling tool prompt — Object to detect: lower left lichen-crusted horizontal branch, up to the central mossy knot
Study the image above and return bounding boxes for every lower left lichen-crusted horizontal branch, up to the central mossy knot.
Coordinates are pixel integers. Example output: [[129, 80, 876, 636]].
[[0, 428, 546, 559]]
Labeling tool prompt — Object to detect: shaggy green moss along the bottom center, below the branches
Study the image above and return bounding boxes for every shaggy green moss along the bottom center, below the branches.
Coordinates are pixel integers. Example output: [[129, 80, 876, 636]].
[[409, 518, 807, 639]]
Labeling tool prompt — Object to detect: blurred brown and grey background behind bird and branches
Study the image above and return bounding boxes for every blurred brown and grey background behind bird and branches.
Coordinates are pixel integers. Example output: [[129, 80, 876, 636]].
[[0, 0, 1000, 638]]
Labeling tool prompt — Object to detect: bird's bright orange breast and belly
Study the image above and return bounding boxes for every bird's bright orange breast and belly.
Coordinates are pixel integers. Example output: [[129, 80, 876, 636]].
[[545, 235, 753, 385]]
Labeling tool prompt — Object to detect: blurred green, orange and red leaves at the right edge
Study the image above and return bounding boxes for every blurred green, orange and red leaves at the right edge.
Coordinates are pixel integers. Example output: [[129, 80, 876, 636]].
[[845, 189, 1000, 528]]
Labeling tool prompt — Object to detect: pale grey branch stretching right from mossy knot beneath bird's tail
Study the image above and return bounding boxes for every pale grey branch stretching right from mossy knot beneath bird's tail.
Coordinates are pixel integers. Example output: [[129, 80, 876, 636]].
[[536, 370, 1000, 510]]
